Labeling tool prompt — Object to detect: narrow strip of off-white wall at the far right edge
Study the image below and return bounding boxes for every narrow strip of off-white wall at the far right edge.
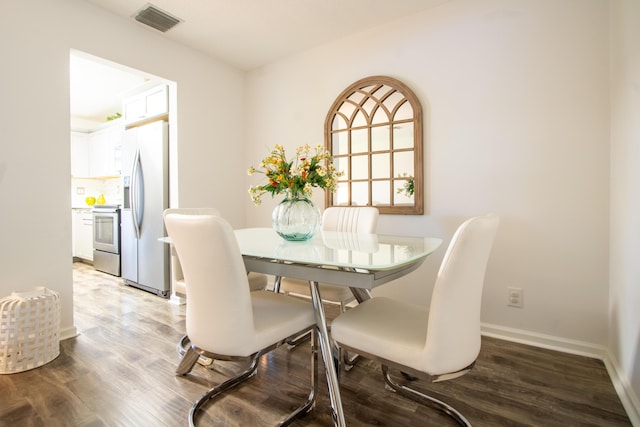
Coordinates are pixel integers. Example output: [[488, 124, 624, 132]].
[[609, 0, 640, 425]]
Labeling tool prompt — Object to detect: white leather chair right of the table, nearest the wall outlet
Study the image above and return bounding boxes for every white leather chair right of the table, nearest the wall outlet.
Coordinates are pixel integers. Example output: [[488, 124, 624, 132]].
[[331, 215, 500, 425]]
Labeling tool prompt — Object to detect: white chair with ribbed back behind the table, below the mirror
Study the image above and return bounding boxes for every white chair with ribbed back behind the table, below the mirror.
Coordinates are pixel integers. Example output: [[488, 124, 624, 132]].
[[280, 206, 378, 312]]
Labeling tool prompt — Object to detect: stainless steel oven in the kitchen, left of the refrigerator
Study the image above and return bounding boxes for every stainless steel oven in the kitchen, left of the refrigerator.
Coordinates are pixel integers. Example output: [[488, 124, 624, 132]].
[[93, 205, 120, 276]]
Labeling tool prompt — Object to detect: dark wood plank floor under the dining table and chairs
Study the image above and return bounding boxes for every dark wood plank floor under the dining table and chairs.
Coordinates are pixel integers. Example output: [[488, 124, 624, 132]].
[[0, 264, 631, 427]]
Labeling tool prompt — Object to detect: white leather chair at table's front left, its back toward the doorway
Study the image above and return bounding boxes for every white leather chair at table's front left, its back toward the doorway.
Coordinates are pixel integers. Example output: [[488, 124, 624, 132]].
[[164, 211, 318, 426]]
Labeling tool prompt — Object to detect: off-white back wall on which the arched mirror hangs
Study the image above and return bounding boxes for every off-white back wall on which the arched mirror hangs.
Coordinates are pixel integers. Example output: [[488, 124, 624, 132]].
[[246, 0, 609, 352]]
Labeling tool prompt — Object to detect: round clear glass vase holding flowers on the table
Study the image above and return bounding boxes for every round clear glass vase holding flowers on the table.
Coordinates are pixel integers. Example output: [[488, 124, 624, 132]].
[[271, 196, 322, 240]]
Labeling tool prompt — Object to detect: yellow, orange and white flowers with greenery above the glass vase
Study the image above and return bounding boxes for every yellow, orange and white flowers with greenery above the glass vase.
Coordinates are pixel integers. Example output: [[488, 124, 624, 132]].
[[247, 144, 343, 205]]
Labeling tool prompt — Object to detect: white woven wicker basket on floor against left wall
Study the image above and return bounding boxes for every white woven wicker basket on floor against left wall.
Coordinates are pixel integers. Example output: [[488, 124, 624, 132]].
[[0, 287, 60, 374]]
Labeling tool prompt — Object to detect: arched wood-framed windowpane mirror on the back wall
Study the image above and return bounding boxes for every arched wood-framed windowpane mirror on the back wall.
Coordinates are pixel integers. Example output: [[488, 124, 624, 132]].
[[325, 76, 424, 215]]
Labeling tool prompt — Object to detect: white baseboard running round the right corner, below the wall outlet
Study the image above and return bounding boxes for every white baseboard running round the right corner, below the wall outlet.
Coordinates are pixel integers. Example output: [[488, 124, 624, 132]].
[[481, 323, 640, 426]]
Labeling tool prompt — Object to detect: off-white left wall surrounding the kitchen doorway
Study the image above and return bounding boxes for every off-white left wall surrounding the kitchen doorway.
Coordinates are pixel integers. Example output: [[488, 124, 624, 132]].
[[0, 0, 245, 336]]
